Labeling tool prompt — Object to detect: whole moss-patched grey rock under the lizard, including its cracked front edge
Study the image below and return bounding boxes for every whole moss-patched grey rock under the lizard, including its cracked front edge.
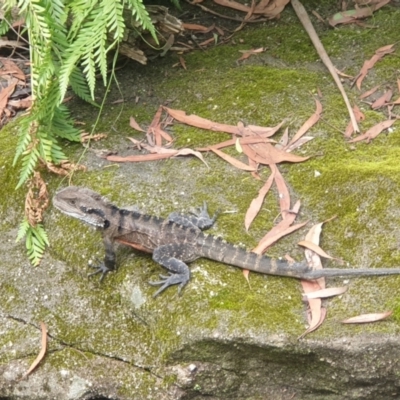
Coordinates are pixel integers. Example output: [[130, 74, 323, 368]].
[[0, 1, 400, 400]]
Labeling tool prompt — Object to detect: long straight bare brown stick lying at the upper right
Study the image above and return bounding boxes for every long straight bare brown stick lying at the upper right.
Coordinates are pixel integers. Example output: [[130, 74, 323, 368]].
[[291, 0, 360, 132]]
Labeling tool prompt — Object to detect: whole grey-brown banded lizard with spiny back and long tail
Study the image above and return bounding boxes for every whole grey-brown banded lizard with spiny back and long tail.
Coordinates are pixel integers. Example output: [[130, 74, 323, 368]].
[[53, 186, 400, 297]]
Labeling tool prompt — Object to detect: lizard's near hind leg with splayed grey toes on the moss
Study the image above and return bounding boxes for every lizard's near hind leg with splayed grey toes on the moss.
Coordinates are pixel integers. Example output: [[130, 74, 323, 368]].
[[149, 244, 197, 297]]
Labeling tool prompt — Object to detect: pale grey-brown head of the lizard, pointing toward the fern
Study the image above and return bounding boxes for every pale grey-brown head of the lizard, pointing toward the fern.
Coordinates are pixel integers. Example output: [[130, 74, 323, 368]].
[[53, 186, 110, 228]]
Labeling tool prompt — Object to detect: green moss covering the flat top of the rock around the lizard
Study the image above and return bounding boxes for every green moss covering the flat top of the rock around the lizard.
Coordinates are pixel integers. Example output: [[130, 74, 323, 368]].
[[0, 1, 400, 398]]
